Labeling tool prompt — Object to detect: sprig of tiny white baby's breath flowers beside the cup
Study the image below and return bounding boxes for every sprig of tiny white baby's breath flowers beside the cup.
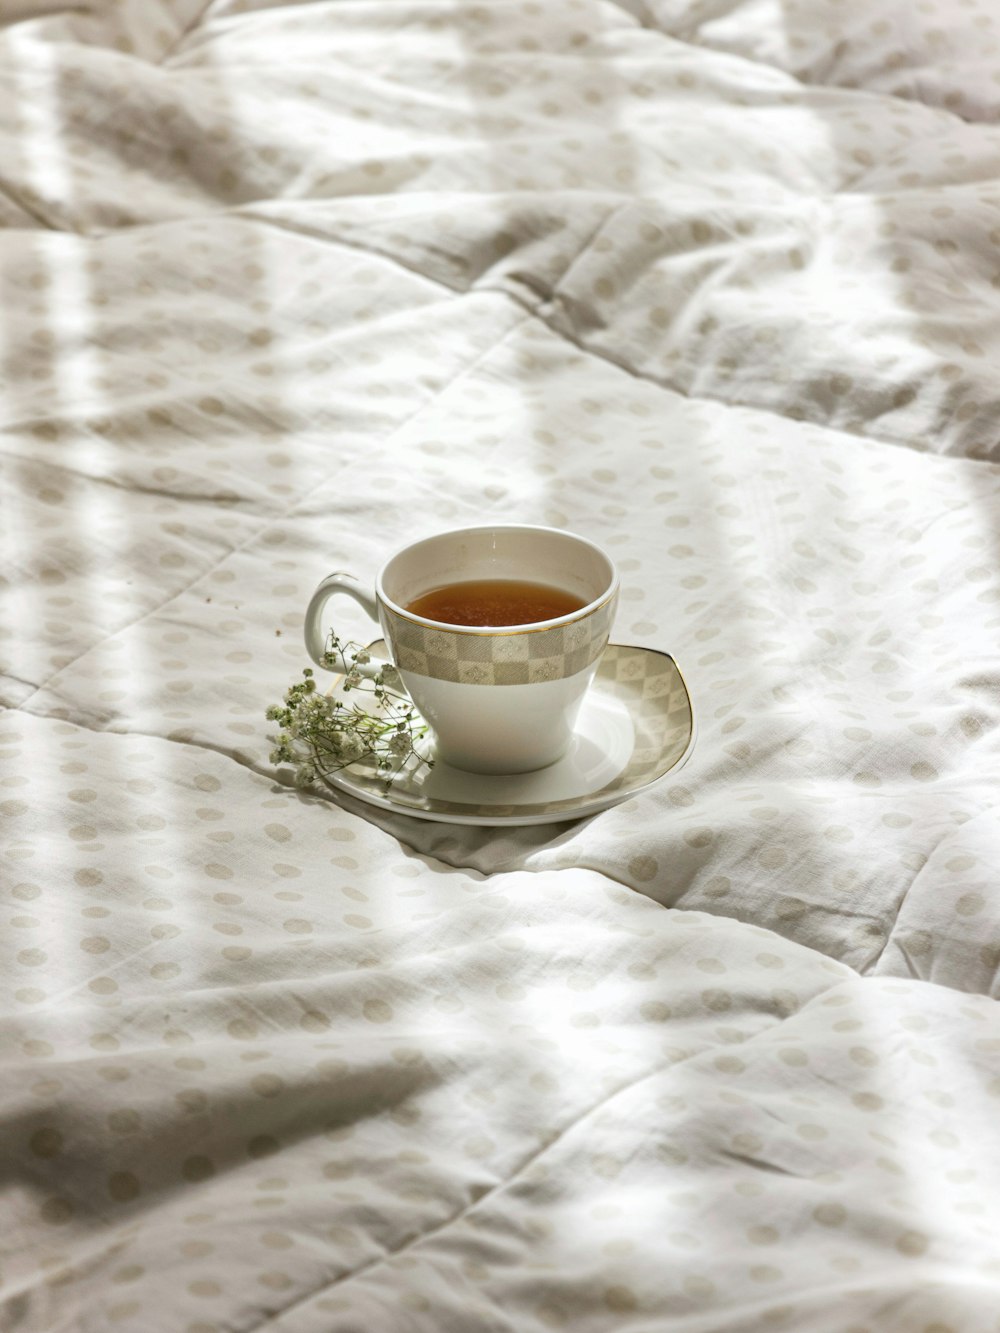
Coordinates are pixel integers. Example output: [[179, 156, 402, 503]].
[[267, 631, 433, 790]]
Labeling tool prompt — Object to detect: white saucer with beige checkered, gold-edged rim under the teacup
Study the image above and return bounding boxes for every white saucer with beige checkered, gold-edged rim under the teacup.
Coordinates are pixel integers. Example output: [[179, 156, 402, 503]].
[[327, 640, 695, 825]]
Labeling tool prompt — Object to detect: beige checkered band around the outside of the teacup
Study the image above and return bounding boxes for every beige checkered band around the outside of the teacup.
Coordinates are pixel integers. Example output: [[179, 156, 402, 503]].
[[380, 592, 617, 685]]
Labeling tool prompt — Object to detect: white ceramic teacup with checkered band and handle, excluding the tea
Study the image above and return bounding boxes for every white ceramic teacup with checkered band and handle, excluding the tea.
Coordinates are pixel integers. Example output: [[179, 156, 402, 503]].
[[305, 524, 619, 773]]
